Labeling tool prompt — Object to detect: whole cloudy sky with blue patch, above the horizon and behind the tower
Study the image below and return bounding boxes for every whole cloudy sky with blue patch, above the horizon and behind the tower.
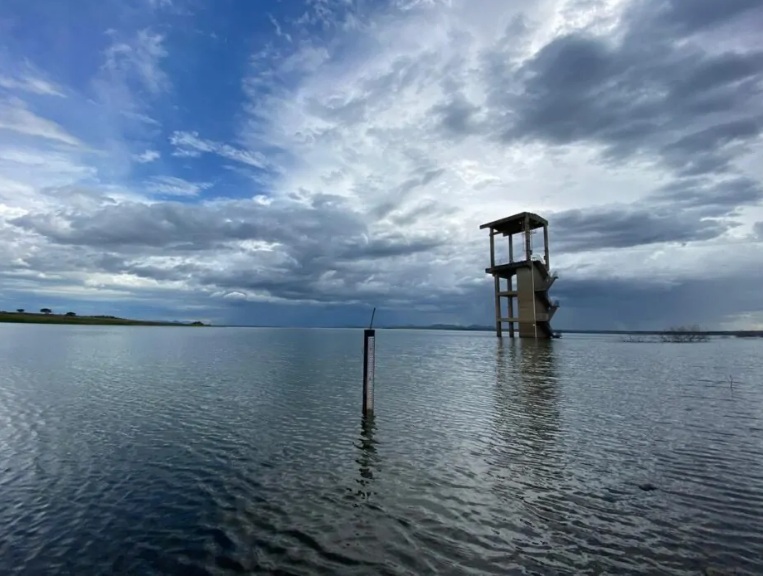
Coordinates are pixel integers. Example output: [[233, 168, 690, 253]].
[[0, 0, 763, 329]]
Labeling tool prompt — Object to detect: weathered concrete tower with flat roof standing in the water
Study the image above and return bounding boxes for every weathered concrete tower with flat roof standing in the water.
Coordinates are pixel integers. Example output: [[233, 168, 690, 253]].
[[480, 212, 559, 339]]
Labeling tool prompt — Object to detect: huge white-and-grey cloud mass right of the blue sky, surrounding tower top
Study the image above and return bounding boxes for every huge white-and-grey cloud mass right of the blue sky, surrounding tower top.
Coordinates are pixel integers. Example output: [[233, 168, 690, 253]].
[[224, 1, 763, 324]]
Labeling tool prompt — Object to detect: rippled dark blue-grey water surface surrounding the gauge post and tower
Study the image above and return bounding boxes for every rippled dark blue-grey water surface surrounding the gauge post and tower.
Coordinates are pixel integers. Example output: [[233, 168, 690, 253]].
[[0, 325, 763, 574]]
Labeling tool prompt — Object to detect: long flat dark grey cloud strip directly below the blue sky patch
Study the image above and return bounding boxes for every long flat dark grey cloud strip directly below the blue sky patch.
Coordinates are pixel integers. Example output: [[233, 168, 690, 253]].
[[11, 194, 438, 259]]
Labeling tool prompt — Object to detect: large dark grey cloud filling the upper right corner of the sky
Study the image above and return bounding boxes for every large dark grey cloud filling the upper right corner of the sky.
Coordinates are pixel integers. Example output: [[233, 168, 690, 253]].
[[489, 1, 763, 182]]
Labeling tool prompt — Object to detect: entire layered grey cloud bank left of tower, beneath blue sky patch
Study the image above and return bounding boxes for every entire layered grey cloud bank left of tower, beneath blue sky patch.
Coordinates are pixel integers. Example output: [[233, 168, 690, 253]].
[[7, 190, 442, 302]]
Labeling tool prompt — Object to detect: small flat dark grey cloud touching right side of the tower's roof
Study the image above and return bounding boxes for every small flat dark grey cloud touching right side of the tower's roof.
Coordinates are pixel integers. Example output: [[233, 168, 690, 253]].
[[549, 206, 729, 252]]
